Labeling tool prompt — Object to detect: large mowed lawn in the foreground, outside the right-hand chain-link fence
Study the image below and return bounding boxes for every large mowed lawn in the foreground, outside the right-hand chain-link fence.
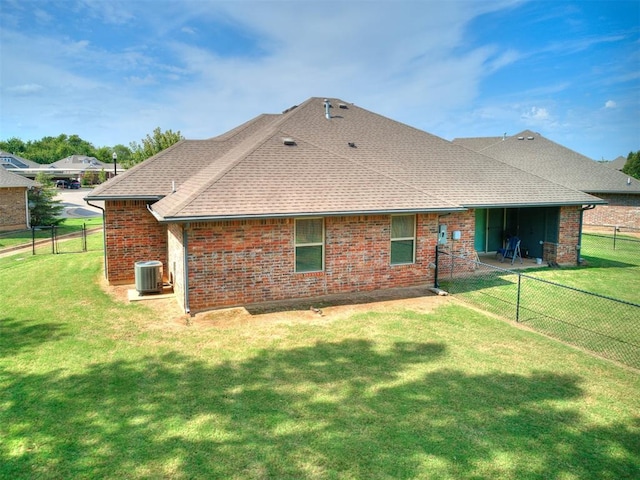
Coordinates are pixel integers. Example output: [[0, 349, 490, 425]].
[[0, 235, 640, 479]]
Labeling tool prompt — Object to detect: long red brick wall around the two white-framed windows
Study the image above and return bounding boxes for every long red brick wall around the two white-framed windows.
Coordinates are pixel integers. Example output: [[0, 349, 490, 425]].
[[178, 215, 448, 312]]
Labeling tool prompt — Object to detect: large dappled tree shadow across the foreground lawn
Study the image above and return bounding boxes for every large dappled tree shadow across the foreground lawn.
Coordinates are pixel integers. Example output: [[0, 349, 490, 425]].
[[0, 340, 639, 479]]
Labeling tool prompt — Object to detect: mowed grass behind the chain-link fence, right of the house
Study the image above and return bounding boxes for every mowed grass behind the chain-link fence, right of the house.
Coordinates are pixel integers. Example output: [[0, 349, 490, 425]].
[[440, 235, 640, 369]]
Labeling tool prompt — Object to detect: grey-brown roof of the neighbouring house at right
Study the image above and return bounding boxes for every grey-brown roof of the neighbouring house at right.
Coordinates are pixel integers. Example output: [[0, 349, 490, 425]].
[[453, 130, 640, 195]]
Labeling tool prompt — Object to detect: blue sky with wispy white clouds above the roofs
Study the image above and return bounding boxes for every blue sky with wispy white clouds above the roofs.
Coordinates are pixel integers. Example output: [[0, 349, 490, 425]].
[[0, 0, 640, 160]]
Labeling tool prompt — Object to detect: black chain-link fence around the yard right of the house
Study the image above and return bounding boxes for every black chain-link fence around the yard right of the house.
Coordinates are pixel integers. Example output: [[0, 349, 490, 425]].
[[436, 232, 640, 369]]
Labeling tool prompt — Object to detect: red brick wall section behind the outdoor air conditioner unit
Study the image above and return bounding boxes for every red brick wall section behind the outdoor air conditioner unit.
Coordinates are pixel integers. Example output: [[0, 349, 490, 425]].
[[105, 200, 167, 284]]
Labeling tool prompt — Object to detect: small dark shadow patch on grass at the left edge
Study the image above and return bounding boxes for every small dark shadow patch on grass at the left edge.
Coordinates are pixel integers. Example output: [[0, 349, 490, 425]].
[[0, 318, 65, 358]]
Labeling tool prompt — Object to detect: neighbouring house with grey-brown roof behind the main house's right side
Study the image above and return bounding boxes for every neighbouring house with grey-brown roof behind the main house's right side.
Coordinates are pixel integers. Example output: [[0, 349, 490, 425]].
[[453, 130, 640, 228]]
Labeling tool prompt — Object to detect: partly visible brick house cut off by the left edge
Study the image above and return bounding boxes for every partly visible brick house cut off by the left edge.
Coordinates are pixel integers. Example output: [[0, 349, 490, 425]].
[[0, 168, 37, 230]]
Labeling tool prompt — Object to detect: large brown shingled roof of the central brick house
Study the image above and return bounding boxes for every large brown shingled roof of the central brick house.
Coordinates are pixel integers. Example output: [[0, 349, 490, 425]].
[[87, 97, 603, 221]]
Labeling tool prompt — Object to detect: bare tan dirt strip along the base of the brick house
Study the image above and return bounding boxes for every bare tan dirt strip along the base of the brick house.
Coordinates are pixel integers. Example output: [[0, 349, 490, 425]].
[[102, 280, 450, 328]]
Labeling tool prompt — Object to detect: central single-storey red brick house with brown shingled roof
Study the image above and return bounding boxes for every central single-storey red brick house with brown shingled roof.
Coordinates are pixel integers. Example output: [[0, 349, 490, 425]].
[[86, 98, 601, 312]]
